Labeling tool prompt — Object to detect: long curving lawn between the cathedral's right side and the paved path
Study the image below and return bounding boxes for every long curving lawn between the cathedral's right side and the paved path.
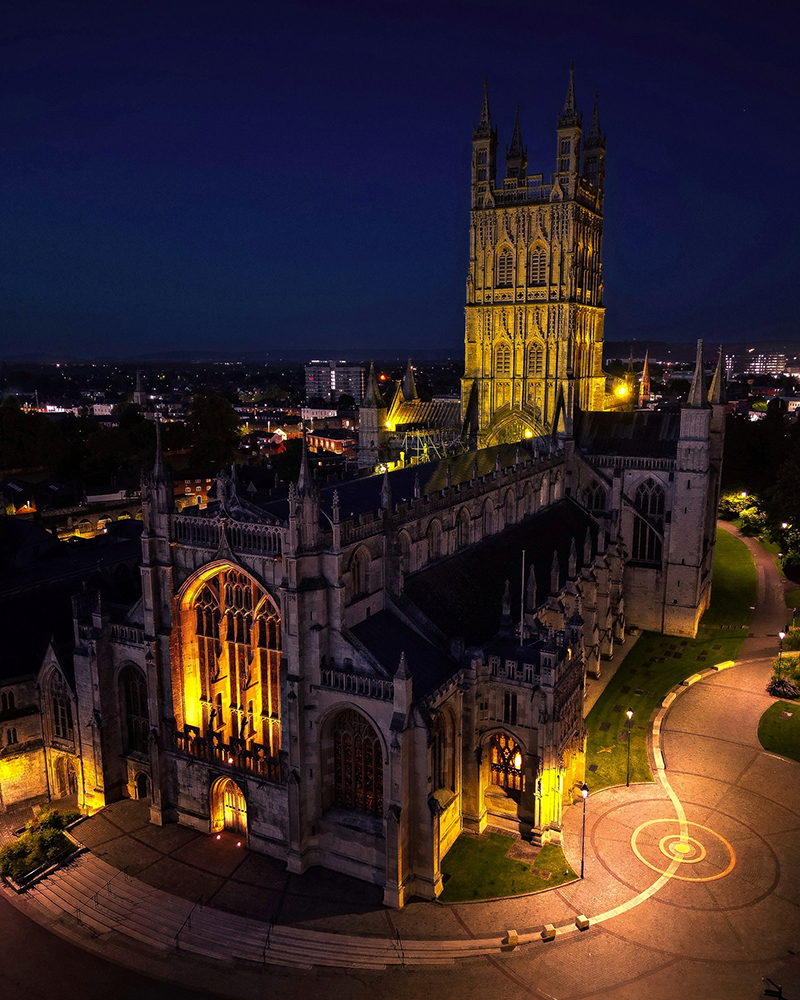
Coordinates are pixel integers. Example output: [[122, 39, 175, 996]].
[[586, 529, 756, 791]]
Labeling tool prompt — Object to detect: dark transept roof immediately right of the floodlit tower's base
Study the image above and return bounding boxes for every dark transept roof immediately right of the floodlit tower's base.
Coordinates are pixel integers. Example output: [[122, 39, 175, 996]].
[[575, 410, 681, 458]]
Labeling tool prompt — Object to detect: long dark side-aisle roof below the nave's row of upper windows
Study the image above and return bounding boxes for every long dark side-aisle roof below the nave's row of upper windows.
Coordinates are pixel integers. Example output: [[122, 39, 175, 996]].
[[405, 499, 597, 646]]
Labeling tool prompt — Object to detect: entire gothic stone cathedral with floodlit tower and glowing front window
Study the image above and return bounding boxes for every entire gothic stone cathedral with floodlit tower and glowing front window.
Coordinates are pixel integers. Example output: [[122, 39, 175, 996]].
[[0, 80, 725, 907]]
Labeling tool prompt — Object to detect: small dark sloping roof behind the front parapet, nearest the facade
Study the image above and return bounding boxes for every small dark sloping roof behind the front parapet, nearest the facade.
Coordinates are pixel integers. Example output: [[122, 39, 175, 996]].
[[350, 611, 459, 699]]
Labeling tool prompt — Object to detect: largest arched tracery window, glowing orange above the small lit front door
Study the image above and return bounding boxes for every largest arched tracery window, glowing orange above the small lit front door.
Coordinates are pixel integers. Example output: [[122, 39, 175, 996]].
[[183, 567, 281, 757]]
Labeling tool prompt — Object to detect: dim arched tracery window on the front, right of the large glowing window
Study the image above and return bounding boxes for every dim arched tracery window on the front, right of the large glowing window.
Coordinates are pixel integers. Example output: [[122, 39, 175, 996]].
[[333, 709, 383, 816]]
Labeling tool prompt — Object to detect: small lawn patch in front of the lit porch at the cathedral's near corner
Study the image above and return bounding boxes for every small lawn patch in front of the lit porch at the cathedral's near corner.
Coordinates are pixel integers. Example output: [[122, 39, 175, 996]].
[[439, 833, 577, 903]]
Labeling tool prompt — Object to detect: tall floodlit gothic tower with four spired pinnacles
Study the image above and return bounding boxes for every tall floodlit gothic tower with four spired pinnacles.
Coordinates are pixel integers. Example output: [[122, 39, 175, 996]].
[[461, 72, 605, 447]]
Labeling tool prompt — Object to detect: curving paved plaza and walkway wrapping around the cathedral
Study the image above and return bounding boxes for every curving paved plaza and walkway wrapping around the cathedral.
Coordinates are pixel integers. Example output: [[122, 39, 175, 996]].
[[3, 528, 800, 1000]]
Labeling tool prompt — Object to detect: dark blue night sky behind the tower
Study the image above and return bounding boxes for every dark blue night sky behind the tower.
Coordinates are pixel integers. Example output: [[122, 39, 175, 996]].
[[0, 0, 800, 356]]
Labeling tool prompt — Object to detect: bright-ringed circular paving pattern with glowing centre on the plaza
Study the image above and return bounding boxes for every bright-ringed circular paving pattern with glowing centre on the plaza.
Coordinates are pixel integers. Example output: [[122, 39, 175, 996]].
[[631, 819, 736, 882]]
